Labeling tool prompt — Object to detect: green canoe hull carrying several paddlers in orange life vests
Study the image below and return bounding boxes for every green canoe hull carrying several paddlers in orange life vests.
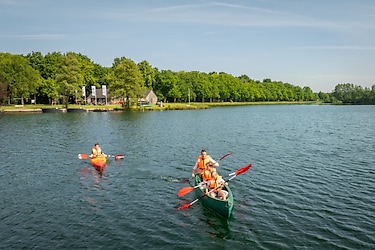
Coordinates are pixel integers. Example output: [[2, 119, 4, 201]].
[[195, 175, 233, 218]]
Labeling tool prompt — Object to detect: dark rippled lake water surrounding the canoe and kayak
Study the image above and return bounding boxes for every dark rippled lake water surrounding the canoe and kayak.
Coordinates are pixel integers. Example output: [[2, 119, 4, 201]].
[[0, 105, 375, 249]]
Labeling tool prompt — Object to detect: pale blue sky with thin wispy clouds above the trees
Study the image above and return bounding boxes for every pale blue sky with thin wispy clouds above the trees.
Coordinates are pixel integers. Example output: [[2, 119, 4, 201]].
[[0, 0, 375, 92]]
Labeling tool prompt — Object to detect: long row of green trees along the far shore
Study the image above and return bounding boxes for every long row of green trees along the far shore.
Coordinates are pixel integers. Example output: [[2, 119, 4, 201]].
[[0, 52, 375, 106]]
